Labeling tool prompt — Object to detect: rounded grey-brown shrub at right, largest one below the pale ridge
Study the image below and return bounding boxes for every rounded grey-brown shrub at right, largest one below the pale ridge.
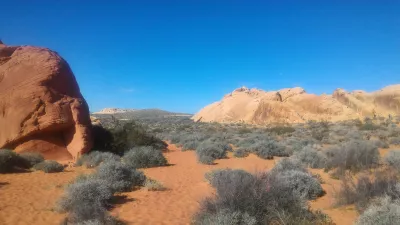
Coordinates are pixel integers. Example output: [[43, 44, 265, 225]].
[[325, 140, 380, 171]]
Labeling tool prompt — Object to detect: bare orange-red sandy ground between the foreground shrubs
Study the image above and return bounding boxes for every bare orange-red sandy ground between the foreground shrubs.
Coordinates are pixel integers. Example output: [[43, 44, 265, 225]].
[[0, 145, 357, 225]]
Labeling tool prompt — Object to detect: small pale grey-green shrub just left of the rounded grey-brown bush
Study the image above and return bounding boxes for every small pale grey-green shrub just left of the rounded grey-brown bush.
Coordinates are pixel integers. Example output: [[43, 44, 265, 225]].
[[294, 146, 326, 168]]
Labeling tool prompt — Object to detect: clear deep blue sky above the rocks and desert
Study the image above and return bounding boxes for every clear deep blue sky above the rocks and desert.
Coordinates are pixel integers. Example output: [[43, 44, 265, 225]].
[[0, 0, 400, 113]]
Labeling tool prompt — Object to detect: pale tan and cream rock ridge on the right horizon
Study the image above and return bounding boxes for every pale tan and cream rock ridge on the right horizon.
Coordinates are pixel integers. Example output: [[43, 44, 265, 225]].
[[192, 85, 400, 124]]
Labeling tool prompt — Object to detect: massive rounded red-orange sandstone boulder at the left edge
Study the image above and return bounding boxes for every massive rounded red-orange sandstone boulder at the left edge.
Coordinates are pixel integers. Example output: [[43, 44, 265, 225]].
[[0, 44, 92, 160]]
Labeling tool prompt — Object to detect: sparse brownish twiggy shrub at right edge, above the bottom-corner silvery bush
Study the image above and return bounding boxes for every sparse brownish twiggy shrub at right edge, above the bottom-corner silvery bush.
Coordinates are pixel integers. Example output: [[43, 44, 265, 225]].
[[336, 171, 400, 212]]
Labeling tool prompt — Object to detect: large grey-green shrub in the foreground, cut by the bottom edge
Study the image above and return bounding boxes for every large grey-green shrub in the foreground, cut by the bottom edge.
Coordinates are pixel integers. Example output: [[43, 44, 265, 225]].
[[194, 169, 330, 224]]
